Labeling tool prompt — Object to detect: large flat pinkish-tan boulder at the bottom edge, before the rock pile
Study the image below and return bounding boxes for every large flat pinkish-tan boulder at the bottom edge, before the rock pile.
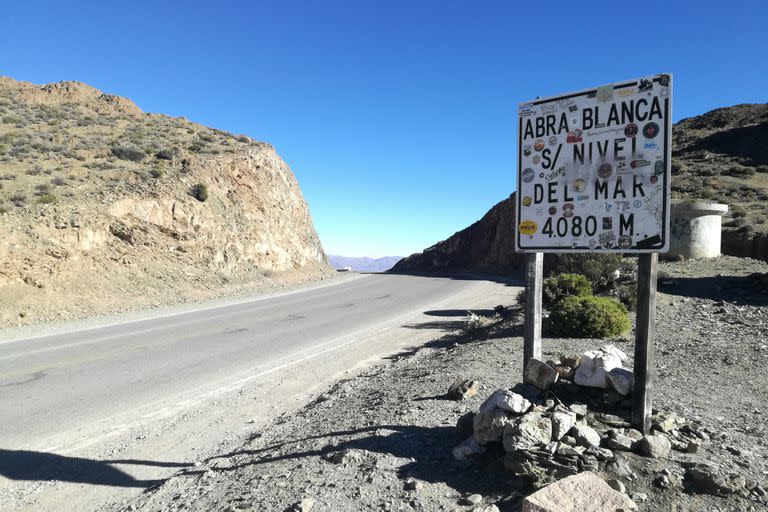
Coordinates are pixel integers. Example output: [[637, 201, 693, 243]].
[[522, 471, 637, 512]]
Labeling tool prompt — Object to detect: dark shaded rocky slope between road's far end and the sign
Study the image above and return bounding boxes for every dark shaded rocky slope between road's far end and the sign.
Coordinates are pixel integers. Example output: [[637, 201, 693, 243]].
[[391, 194, 525, 274]]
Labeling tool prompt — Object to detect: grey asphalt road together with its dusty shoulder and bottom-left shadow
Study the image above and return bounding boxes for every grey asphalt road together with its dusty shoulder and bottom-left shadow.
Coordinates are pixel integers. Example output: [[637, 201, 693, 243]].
[[0, 274, 517, 512]]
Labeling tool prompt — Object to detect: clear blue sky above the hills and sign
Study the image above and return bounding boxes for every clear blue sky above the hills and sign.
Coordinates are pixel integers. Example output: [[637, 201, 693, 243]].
[[0, 0, 768, 256]]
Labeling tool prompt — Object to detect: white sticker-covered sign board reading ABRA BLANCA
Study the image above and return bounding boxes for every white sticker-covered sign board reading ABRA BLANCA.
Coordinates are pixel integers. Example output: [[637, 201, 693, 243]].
[[515, 74, 672, 253]]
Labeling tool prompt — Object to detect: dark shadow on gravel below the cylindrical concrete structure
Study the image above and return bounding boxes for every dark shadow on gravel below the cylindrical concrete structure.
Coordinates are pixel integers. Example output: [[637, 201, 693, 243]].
[[658, 276, 768, 306]]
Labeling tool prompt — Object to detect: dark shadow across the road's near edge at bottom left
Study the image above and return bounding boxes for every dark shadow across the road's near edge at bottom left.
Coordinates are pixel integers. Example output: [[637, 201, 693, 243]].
[[0, 449, 189, 489]]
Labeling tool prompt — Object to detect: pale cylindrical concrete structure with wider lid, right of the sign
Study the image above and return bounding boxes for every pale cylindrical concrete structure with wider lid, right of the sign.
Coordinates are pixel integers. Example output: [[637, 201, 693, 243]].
[[669, 202, 728, 259]]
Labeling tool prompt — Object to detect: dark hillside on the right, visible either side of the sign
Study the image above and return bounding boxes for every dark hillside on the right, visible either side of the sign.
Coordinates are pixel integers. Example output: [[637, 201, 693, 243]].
[[392, 104, 768, 273]]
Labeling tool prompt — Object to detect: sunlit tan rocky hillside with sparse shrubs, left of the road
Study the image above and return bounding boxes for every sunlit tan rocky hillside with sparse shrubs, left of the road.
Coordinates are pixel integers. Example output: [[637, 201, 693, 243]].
[[0, 78, 330, 327]]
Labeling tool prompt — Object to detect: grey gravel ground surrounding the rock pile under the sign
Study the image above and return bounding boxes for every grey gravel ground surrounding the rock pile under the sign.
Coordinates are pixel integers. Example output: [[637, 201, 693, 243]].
[[121, 257, 768, 512]]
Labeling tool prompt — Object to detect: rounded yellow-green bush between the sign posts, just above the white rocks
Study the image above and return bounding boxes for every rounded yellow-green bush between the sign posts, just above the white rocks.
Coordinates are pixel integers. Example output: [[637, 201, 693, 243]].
[[549, 296, 630, 338]]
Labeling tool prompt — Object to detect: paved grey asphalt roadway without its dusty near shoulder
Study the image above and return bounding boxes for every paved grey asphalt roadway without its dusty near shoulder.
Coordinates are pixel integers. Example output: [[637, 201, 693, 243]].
[[0, 275, 484, 450]]
